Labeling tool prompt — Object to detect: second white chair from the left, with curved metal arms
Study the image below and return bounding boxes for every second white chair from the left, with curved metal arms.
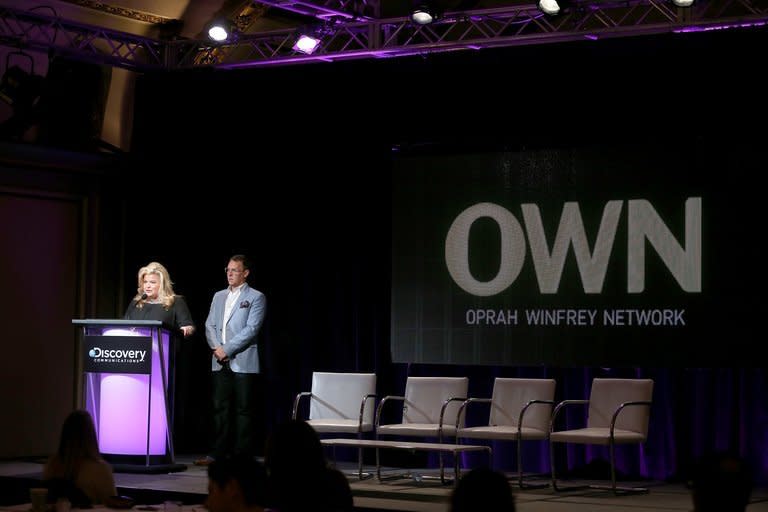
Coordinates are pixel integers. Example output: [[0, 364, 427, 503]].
[[376, 377, 469, 483]]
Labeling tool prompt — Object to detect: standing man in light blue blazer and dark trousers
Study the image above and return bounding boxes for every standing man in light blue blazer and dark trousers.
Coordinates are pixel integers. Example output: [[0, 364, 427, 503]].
[[195, 254, 267, 465]]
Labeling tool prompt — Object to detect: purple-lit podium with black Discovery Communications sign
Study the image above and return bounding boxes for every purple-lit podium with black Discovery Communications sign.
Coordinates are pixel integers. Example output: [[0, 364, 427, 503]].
[[72, 319, 187, 473]]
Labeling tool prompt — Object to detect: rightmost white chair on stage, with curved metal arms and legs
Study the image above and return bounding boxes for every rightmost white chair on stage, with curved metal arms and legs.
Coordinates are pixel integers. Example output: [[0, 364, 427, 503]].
[[549, 379, 653, 494]]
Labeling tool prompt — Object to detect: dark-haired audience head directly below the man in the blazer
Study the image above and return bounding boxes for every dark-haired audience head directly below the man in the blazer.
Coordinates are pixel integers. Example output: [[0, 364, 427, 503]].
[[206, 457, 267, 512]]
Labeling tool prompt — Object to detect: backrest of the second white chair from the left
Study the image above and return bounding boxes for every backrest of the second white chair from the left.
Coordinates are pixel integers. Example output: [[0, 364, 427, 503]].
[[403, 377, 469, 426]]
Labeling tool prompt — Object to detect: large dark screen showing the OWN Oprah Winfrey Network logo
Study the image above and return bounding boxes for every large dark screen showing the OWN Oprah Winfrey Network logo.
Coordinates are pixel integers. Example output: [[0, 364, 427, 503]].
[[391, 144, 768, 367]]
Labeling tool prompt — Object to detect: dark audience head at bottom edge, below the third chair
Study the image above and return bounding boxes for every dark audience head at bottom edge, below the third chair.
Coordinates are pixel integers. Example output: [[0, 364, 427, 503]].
[[451, 468, 515, 512]]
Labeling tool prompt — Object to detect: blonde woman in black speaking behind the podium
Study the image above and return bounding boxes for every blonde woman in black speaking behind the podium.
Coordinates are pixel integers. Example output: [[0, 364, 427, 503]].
[[125, 261, 195, 338]]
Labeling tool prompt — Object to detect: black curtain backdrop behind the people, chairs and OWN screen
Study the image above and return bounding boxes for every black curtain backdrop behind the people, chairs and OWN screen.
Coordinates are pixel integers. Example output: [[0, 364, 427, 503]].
[[129, 25, 768, 484]]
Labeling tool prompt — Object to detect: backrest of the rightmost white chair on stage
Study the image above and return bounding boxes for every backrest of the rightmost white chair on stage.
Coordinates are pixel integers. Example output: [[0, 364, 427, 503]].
[[587, 379, 653, 438]]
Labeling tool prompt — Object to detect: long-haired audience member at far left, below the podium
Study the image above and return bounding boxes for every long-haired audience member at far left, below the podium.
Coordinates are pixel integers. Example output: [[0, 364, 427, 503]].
[[43, 410, 117, 505]]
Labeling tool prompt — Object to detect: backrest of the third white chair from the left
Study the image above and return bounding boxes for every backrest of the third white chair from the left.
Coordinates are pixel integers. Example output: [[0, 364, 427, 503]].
[[488, 377, 555, 431]]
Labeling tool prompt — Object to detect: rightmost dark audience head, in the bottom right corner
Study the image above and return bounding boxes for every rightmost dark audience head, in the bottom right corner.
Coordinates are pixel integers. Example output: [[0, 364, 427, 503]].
[[691, 453, 752, 512]]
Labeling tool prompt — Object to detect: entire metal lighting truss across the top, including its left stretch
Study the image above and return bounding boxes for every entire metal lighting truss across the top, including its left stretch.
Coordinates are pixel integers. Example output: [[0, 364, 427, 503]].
[[0, 0, 768, 70]]
